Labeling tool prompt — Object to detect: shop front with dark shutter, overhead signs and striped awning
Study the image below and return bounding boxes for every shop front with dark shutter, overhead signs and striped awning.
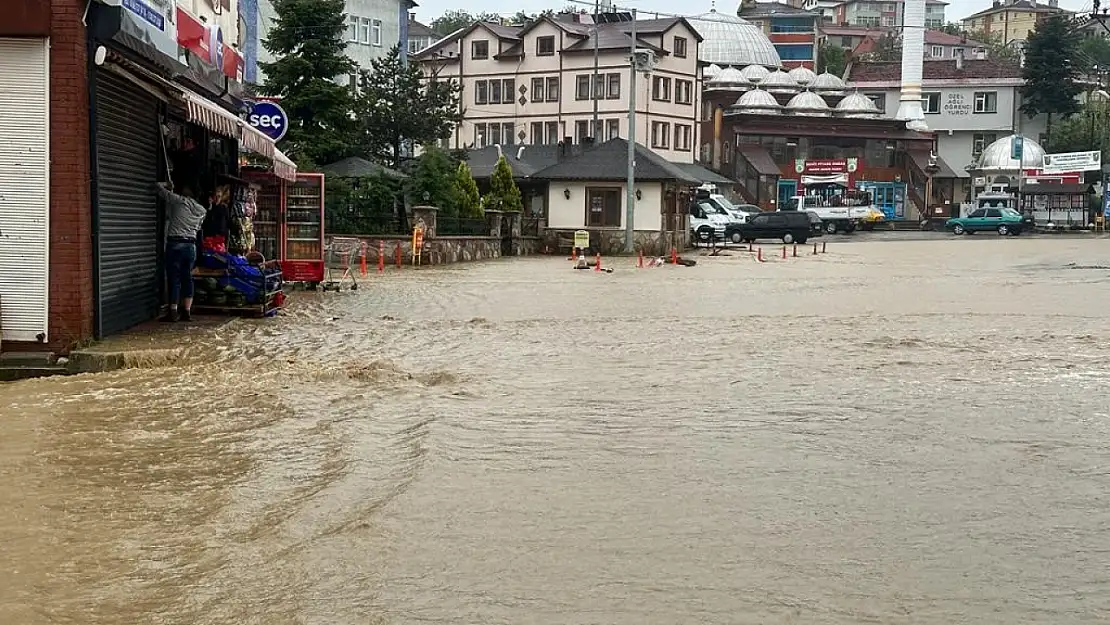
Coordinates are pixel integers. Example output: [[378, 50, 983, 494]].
[[90, 3, 295, 336]]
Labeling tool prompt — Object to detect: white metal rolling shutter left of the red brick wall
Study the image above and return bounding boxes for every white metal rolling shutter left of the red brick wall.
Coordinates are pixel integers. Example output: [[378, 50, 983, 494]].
[[0, 39, 50, 341]]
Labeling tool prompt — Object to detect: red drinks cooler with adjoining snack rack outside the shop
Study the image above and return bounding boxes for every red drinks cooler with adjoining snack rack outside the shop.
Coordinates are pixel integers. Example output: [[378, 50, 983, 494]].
[[245, 172, 324, 284]]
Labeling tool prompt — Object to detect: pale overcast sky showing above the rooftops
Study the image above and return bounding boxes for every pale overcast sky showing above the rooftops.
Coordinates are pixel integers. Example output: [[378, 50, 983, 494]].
[[415, 0, 1092, 23]]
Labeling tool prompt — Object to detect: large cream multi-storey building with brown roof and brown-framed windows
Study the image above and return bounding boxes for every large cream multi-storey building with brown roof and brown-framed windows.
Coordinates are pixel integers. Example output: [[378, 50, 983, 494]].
[[413, 14, 702, 163]]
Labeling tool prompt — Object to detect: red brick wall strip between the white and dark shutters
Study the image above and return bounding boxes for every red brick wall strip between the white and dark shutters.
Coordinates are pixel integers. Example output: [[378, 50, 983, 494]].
[[47, 0, 93, 351]]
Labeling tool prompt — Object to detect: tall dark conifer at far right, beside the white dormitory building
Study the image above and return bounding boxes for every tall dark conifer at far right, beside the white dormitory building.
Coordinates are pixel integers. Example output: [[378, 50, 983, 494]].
[[1021, 16, 1082, 137]]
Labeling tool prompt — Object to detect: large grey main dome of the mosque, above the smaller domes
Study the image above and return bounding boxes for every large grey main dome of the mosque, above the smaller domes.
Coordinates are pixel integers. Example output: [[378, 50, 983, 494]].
[[686, 11, 783, 68]]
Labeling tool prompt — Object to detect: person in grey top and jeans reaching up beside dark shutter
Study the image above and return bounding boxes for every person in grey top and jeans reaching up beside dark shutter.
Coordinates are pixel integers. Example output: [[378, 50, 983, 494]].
[[158, 182, 208, 323]]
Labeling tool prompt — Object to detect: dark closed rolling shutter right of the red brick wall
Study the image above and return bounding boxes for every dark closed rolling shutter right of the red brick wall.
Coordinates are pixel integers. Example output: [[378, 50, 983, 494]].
[[97, 70, 162, 336]]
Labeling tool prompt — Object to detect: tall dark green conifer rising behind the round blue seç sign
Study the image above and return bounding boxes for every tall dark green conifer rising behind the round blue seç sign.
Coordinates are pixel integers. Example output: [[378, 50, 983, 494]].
[[260, 0, 353, 168]]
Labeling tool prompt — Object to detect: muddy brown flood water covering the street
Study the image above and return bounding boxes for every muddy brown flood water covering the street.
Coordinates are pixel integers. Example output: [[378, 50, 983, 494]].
[[0, 235, 1110, 625]]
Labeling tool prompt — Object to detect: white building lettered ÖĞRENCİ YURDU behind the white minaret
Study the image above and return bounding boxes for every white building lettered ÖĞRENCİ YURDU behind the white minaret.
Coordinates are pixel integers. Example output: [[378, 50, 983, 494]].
[[847, 57, 1046, 196]]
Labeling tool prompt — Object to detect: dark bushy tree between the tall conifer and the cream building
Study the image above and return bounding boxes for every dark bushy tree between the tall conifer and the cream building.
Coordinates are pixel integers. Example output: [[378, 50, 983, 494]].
[[354, 47, 462, 169]]
